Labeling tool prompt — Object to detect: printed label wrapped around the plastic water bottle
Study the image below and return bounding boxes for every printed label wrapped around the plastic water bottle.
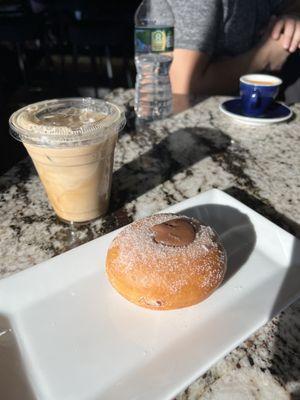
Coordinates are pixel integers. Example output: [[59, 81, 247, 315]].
[[135, 27, 174, 53]]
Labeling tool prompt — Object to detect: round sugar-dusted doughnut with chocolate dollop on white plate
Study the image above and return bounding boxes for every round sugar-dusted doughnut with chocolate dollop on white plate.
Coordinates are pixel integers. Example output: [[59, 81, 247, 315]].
[[106, 214, 226, 310]]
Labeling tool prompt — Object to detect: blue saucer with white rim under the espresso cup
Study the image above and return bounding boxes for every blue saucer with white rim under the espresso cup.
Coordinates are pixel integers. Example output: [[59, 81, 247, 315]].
[[220, 98, 293, 125]]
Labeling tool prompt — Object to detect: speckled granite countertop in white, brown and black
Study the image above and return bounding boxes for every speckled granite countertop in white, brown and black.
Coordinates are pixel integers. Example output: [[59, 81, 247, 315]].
[[0, 89, 300, 400]]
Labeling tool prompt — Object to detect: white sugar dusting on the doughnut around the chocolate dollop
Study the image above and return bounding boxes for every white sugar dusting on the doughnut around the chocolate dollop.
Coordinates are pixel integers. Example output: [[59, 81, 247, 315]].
[[110, 214, 226, 293]]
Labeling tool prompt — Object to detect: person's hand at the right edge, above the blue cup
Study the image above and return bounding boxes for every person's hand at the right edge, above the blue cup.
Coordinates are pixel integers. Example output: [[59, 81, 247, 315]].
[[272, 15, 300, 53]]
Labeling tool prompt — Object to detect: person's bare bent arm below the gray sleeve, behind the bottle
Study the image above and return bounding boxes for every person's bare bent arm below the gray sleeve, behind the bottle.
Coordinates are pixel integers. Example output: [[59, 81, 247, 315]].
[[170, 34, 289, 95]]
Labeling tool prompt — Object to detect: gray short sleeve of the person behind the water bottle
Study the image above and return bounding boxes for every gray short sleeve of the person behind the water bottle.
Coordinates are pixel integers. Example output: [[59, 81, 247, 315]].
[[169, 0, 223, 55]]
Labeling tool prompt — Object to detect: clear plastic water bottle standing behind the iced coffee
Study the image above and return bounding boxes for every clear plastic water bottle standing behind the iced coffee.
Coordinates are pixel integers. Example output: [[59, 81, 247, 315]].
[[135, 0, 174, 122]]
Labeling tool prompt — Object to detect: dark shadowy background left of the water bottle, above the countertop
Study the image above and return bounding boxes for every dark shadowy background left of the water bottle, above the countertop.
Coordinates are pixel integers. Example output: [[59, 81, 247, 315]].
[[0, 0, 140, 173]]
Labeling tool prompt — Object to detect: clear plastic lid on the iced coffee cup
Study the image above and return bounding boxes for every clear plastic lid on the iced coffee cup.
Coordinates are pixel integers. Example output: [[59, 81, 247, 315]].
[[9, 98, 125, 147]]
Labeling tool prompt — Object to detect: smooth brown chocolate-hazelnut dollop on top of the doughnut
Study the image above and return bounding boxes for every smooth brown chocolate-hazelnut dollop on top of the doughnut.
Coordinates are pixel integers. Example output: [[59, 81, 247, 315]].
[[150, 218, 196, 247]]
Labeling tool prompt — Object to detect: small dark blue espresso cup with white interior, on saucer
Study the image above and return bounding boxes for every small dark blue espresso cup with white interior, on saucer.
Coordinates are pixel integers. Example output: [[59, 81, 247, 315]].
[[240, 74, 282, 117]]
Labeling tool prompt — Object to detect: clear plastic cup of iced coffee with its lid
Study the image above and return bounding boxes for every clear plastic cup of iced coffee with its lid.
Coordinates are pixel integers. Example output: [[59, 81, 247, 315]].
[[9, 98, 125, 222]]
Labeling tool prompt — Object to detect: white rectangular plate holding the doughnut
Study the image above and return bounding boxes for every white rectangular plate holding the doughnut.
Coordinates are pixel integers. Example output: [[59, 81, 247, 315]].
[[0, 190, 300, 400]]
